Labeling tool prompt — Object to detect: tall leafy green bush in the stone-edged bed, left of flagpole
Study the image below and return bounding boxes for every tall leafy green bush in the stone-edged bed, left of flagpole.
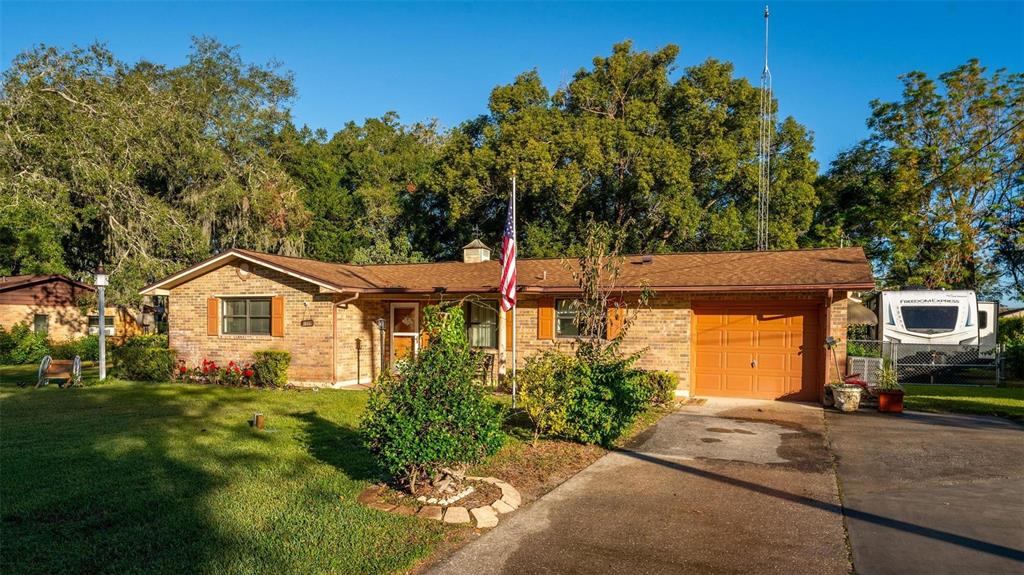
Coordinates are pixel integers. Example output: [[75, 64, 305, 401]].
[[360, 306, 504, 493]]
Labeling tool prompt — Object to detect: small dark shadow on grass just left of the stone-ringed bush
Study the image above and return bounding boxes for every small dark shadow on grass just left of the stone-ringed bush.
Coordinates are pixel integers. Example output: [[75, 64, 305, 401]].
[[289, 411, 388, 481]]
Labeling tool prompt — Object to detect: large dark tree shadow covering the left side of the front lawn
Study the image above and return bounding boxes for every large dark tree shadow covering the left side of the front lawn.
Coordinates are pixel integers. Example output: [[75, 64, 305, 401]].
[[0, 386, 287, 573]]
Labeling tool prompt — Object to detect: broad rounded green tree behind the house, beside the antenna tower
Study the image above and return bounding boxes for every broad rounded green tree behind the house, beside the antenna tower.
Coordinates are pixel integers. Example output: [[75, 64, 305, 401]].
[[417, 42, 817, 256]]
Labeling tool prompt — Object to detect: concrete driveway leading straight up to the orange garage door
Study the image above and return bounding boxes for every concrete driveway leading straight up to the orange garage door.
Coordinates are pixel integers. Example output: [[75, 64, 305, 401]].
[[431, 399, 850, 575]]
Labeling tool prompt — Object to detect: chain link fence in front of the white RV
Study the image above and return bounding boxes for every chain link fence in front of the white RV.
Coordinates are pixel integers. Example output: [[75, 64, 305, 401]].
[[846, 340, 1002, 386]]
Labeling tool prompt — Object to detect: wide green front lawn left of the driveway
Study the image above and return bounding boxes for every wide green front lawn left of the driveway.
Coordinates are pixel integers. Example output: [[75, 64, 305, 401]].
[[0, 367, 445, 574]]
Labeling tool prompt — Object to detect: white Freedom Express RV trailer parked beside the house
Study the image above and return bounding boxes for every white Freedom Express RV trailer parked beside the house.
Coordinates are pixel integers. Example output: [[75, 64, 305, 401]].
[[877, 290, 999, 353]]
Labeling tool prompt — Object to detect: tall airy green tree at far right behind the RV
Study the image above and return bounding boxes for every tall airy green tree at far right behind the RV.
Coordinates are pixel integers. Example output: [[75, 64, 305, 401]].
[[814, 60, 1024, 295]]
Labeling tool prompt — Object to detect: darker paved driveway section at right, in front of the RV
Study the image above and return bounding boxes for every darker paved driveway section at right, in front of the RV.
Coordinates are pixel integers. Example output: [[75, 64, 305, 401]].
[[827, 410, 1024, 575]]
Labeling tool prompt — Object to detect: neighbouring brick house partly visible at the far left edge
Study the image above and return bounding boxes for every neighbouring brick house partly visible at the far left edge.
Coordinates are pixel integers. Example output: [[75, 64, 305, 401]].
[[0, 274, 142, 342]]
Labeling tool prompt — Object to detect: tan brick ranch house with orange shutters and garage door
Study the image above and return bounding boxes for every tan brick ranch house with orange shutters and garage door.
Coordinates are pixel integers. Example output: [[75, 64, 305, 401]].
[[141, 241, 873, 400]]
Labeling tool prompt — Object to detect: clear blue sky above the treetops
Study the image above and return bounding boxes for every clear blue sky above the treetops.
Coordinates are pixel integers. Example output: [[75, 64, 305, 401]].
[[0, 1, 1024, 167]]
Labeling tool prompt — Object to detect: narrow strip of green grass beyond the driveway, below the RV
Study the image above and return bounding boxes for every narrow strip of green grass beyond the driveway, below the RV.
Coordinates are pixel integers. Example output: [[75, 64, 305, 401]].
[[903, 385, 1024, 419]]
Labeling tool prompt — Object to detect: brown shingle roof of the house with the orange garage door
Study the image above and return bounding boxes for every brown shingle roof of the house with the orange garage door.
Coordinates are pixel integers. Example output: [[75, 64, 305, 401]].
[[143, 248, 874, 293]]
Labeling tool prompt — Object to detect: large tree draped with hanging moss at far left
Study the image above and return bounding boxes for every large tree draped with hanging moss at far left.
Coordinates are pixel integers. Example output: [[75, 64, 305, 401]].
[[0, 39, 307, 303]]
